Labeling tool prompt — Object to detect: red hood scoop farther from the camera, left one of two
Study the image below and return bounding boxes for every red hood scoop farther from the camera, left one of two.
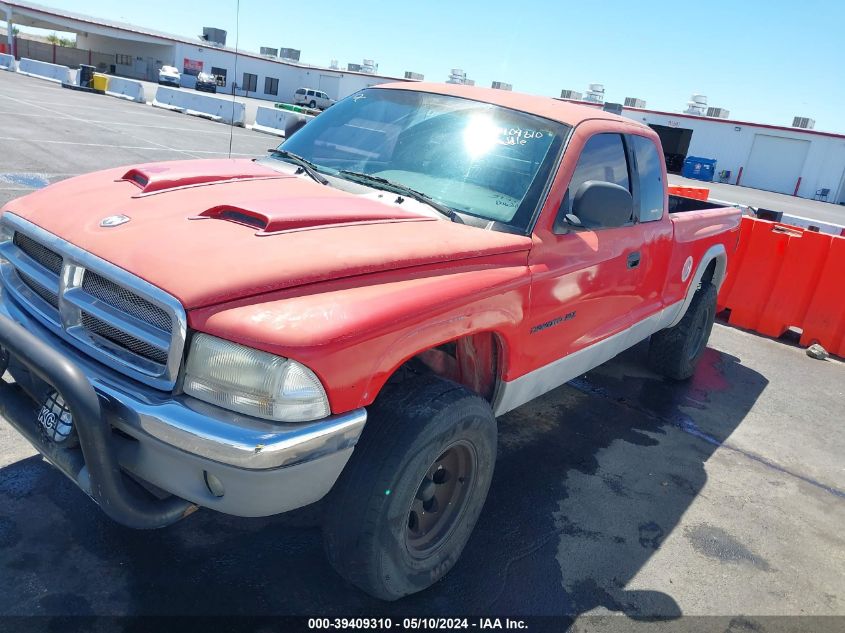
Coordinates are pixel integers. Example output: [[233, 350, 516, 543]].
[[117, 160, 292, 198]]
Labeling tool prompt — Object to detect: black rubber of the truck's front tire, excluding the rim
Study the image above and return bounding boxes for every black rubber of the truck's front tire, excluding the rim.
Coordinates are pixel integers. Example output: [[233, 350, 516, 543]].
[[323, 375, 497, 600]]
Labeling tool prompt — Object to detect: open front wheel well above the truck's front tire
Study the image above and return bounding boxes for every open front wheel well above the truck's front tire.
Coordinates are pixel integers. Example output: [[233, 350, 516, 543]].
[[388, 332, 503, 403]]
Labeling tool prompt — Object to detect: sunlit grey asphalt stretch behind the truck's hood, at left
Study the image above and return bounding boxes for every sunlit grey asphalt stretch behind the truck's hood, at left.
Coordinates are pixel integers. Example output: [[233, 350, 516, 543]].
[[0, 72, 272, 205]]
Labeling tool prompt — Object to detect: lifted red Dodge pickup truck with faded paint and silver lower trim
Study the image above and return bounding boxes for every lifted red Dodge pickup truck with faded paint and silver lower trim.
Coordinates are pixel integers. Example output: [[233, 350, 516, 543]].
[[0, 83, 740, 600]]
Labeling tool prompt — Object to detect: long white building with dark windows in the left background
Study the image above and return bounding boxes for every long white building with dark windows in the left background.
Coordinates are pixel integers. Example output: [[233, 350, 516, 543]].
[[0, 0, 414, 101]]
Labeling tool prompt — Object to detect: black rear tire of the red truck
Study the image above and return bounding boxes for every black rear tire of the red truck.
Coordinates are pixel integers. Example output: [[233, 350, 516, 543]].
[[648, 283, 716, 380]]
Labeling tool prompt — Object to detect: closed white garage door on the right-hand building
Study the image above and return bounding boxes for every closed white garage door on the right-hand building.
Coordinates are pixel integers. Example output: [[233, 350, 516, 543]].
[[741, 134, 810, 194]]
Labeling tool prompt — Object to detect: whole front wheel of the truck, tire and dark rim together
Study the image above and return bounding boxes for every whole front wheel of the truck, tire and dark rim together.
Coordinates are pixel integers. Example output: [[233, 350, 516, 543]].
[[323, 376, 496, 600]]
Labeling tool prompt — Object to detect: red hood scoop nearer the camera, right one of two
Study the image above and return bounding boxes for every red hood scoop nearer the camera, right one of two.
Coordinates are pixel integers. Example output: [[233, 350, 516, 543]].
[[189, 197, 428, 236]]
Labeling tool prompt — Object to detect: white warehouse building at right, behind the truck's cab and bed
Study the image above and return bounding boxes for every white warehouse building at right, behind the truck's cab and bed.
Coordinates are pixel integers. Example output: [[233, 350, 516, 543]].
[[562, 90, 845, 204]]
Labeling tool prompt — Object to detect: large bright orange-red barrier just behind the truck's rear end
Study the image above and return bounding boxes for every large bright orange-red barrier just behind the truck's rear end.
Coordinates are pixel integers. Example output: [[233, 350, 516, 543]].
[[718, 217, 845, 357]]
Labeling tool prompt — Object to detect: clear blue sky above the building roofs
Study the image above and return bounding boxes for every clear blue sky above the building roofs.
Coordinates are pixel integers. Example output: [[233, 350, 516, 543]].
[[13, 0, 845, 132]]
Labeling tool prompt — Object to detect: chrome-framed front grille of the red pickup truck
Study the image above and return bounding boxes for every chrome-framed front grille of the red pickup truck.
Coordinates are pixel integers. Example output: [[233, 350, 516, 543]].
[[0, 212, 187, 390]]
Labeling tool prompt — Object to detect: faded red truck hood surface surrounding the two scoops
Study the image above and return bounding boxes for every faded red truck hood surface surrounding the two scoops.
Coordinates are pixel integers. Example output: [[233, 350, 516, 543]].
[[6, 160, 531, 310]]
